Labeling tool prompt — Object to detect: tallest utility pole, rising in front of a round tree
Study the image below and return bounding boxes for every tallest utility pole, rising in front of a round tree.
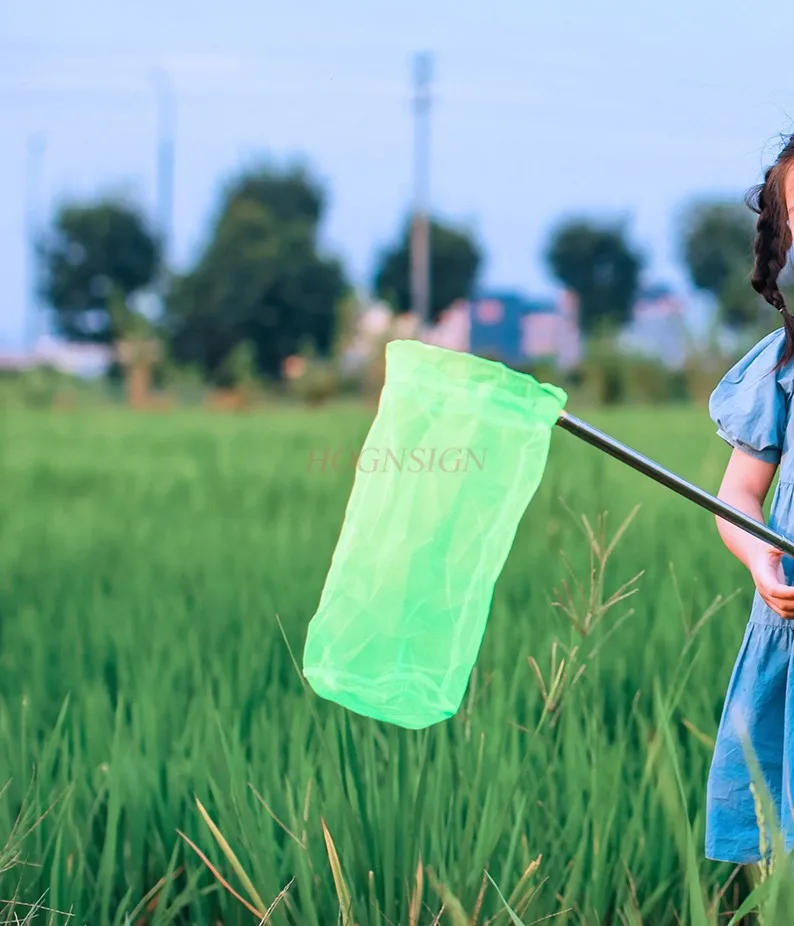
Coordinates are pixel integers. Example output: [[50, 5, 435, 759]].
[[411, 52, 433, 327]]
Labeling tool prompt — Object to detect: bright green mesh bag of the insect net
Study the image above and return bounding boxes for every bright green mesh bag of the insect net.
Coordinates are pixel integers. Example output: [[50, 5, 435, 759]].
[[304, 341, 567, 729]]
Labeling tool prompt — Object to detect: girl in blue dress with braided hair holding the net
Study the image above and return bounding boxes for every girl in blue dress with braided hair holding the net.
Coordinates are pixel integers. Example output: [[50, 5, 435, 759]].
[[706, 135, 794, 864]]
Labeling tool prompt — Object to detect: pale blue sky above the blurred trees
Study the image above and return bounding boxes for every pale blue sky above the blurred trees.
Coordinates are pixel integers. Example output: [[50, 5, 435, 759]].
[[0, 0, 794, 348]]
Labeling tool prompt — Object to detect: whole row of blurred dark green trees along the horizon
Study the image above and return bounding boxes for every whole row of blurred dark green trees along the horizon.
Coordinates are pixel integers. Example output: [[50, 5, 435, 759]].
[[38, 158, 772, 382]]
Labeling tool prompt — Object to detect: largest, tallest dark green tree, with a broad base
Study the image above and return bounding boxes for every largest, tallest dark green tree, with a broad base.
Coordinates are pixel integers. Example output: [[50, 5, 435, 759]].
[[167, 170, 346, 379]]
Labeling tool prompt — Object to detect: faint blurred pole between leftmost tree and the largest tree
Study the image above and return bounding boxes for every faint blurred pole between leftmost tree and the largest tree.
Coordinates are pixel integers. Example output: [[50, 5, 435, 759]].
[[152, 68, 176, 314]]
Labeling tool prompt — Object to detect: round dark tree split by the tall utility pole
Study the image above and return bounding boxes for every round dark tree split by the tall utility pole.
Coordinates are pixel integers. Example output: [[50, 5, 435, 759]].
[[374, 221, 482, 322]]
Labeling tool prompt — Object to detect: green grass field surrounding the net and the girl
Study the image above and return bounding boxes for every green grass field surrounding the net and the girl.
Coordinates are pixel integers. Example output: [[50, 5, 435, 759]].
[[0, 408, 790, 926]]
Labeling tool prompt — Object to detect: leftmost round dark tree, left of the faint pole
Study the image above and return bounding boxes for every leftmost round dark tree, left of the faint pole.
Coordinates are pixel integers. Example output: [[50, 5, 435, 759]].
[[39, 199, 159, 344]]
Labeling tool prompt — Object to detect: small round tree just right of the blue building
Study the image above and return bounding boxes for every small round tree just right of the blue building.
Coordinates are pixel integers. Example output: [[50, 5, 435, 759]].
[[546, 219, 643, 332]]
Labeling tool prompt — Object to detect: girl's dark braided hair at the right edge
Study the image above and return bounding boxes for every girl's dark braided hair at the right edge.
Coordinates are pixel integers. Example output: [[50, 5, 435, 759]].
[[746, 135, 794, 366]]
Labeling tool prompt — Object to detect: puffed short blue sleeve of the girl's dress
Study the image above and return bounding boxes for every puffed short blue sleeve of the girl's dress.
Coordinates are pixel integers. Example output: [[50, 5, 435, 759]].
[[709, 329, 791, 463]]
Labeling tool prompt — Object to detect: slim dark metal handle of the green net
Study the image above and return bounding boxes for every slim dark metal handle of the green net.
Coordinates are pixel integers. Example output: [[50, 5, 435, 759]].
[[557, 412, 794, 556]]
